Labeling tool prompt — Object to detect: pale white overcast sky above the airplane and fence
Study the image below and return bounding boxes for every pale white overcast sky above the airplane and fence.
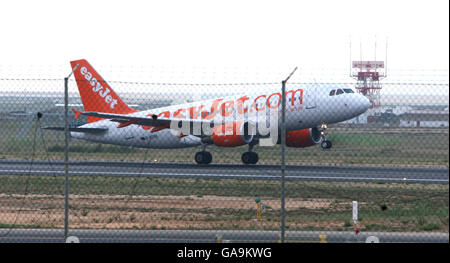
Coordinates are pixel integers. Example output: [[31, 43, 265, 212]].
[[0, 0, 449, 87]]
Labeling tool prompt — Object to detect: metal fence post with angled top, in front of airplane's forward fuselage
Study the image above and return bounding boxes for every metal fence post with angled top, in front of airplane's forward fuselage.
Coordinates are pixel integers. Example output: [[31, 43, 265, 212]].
[[280, 67, 297, 243]]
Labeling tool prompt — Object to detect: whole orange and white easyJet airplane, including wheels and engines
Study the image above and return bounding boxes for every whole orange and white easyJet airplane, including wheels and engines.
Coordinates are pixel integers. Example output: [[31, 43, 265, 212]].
[[47, 59, 371, 164]]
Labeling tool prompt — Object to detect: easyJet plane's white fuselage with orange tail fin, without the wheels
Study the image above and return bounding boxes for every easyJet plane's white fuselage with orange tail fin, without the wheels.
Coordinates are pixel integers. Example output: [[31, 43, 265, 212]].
[[66, 60, 370, 157]]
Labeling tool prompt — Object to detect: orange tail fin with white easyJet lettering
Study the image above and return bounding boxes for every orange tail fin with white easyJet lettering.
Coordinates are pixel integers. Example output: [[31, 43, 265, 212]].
[[70, 59, 136, 122]]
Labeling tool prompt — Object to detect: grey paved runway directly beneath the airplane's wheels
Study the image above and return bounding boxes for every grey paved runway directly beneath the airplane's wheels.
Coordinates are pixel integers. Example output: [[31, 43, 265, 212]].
[[0, 160, 449, 184]]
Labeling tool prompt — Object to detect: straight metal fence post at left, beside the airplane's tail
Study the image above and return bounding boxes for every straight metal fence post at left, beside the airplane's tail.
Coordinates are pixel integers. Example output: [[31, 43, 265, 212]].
[[64, 77, 69, 242]]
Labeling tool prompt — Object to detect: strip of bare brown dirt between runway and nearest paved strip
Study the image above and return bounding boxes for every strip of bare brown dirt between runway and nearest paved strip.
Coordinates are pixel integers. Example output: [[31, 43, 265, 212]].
[[0, 194, 334, 229]]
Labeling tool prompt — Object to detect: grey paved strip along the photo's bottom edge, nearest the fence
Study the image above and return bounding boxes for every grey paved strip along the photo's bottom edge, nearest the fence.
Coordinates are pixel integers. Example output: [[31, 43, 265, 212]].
[[0, 229, 449, 243]]
